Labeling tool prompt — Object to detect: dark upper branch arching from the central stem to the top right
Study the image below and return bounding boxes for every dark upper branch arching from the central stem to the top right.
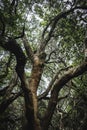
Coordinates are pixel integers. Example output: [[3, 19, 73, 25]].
[[40, 6, 87, 51]]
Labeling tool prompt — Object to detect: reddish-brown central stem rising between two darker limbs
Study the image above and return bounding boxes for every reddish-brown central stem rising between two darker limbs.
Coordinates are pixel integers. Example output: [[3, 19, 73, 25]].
[[29, 54, 45, 130]]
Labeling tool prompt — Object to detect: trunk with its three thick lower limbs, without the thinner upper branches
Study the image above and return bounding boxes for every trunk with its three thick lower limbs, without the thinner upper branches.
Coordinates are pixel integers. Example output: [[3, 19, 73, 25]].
[[1, 35, 87, 130]]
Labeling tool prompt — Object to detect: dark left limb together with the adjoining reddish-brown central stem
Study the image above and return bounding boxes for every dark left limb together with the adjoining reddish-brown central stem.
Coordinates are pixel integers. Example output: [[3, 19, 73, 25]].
[[1, 36, 42, 130]]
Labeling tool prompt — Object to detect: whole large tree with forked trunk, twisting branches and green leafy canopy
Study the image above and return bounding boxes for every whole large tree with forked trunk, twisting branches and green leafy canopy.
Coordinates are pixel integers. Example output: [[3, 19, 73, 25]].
[[0, 0, 87, 130]]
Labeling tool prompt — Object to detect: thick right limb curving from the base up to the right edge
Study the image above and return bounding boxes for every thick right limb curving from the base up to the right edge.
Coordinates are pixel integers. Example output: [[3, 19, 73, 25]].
[[43, 62, 87, 130]]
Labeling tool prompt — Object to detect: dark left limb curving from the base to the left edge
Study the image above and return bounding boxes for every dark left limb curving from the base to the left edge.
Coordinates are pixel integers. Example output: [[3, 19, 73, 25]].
[[0, 39, 35, 130]]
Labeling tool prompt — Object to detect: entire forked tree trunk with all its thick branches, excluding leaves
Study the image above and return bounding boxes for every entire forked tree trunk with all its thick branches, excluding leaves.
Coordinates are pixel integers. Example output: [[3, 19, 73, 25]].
[[0, 0, 87, 130]]
